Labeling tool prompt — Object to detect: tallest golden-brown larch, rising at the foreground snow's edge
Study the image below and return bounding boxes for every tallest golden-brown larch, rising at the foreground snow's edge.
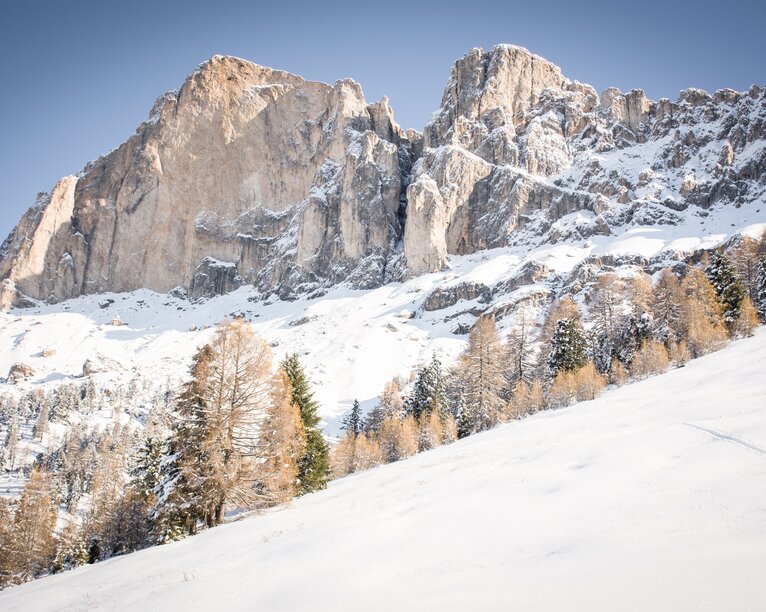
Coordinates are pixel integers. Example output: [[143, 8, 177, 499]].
[[155, 320, 271, 538]]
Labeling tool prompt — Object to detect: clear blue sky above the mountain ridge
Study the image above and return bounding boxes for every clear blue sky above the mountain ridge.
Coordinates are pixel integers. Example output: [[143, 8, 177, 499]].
[[0, 0, 766, 240]]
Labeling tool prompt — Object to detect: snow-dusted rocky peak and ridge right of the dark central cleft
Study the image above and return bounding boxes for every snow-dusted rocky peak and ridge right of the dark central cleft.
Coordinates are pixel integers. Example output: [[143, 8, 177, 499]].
[[404, 45, 766, 273]]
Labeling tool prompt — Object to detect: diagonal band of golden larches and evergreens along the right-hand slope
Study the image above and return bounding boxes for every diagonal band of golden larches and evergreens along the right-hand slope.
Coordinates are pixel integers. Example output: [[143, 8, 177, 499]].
[[332, 238, 766, 477]]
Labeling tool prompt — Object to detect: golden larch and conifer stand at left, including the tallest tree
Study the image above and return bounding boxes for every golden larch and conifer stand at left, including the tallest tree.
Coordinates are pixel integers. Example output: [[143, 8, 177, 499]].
[[0, 320, 330, 586]]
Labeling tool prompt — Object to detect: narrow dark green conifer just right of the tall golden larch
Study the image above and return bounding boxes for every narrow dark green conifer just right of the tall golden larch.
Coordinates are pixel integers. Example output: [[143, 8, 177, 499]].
[[282, 355, 330, 495]]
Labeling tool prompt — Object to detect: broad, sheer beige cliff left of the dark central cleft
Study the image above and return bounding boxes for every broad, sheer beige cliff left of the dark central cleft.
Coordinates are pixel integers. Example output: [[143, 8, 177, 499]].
[[0, 57, 411, 303]]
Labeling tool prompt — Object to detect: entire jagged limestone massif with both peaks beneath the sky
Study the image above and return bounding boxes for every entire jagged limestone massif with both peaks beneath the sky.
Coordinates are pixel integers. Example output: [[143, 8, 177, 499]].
[[0, 45, 766, 306]]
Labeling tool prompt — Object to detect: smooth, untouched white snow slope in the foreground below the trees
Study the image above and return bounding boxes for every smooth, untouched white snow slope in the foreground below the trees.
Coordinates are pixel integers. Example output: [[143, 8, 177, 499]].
[[0, 330, 766, 612]]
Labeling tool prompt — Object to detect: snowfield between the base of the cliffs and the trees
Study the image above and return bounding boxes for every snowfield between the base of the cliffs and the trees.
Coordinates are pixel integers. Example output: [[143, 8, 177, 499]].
[[0, 206, 766, 435]]
